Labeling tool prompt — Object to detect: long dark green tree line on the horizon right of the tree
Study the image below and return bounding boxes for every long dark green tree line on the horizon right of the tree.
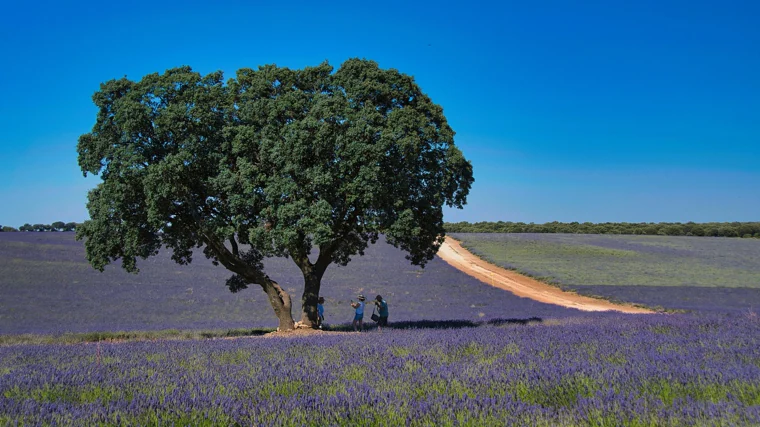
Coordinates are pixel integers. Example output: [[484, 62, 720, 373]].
[[444, 221, 760, 238]]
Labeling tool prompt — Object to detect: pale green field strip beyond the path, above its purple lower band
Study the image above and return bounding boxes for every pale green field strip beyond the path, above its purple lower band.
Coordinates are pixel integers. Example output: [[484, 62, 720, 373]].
[[452, 233, 760, 289]]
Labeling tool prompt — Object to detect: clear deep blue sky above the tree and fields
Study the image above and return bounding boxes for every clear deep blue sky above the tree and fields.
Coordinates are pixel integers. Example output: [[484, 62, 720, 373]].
[[0, 0, 760, 227]]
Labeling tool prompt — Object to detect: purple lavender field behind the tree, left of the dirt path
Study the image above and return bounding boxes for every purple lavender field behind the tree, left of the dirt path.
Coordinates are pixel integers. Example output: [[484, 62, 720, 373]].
[[0, 233, 582, 334]]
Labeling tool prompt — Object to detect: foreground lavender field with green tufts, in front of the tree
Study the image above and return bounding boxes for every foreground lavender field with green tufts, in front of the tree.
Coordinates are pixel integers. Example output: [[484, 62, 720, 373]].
[[0, 315, 760, 426]]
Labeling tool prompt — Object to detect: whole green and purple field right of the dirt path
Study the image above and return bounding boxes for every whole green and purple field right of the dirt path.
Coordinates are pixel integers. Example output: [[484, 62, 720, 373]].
[[452, 233, 760, 312]]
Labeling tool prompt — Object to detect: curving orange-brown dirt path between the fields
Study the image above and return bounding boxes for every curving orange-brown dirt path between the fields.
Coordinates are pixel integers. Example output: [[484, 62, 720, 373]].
[[438, 237, 654, 314]]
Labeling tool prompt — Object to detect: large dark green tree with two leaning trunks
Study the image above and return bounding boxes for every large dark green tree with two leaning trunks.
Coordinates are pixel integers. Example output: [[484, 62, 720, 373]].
[[77, 59, 473, 330]]
